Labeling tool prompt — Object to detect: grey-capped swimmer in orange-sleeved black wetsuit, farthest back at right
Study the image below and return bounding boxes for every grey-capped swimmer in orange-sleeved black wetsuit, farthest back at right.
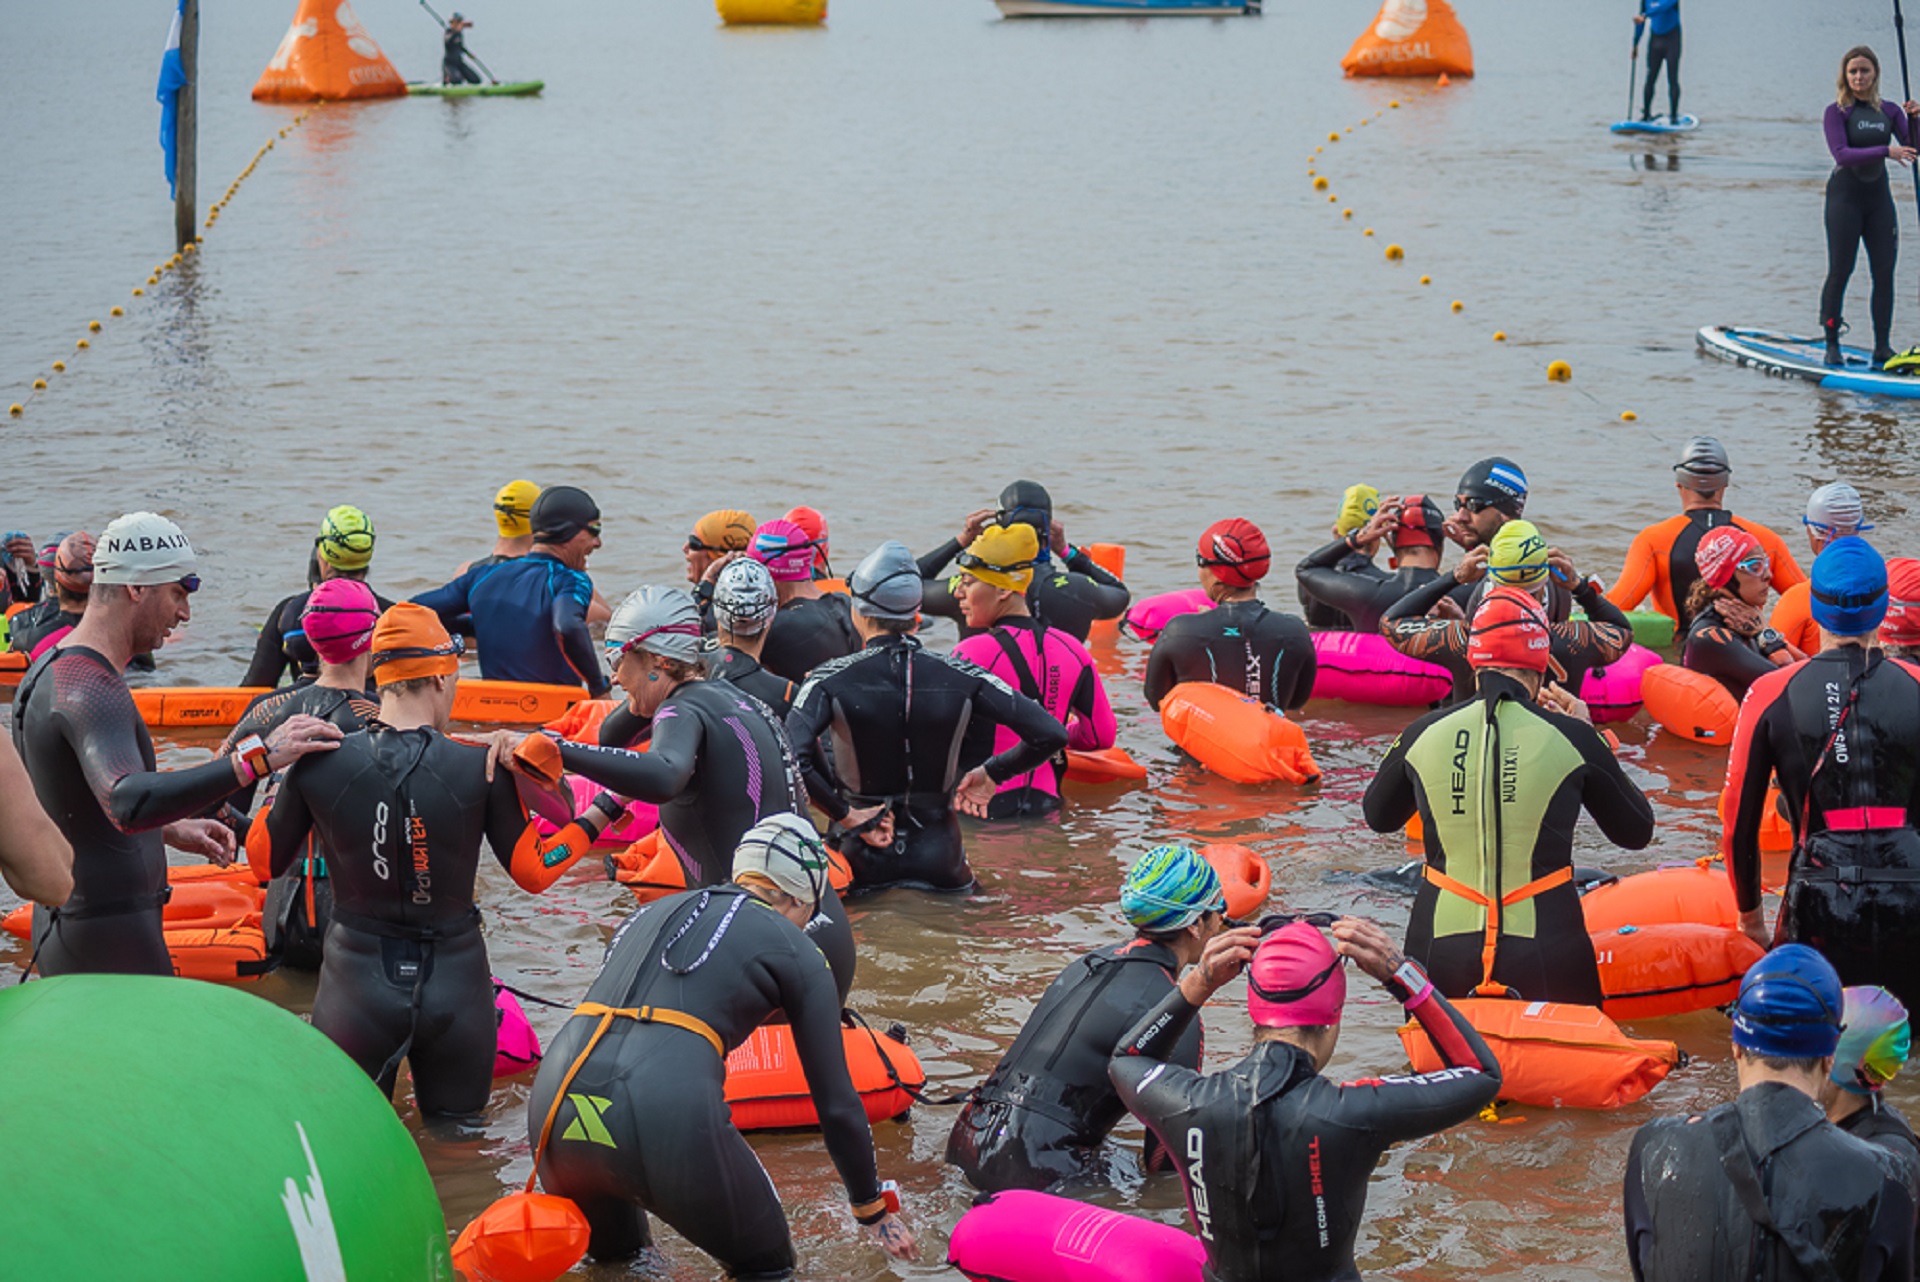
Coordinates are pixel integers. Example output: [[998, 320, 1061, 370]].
[[1607, 436, 1807, 637]]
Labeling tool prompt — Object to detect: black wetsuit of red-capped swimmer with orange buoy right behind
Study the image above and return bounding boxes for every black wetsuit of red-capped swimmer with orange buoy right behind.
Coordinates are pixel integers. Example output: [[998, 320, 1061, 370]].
[[1146, 601, 1319, 708]]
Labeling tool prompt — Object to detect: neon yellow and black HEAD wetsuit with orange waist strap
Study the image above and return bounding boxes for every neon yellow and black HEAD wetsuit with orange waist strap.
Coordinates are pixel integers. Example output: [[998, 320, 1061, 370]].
[[1365, 672, 1653, 1006]]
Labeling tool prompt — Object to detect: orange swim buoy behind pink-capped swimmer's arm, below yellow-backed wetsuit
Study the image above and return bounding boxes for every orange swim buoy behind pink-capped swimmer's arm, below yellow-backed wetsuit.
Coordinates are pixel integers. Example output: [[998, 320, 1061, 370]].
[[1400, 998, 1680, 1109]]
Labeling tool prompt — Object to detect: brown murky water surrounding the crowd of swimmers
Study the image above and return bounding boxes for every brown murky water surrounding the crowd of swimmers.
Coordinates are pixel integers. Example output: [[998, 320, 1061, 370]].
[[11, 0, 1920, 1280]]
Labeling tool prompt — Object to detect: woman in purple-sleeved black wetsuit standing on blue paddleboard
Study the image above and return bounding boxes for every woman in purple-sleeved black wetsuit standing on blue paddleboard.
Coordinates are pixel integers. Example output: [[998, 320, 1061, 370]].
[[1820, 44, 1920, 368]]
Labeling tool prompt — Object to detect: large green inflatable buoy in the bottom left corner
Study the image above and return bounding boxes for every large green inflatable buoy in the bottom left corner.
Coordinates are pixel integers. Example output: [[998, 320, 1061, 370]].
[[0, 975, 457, 1282]]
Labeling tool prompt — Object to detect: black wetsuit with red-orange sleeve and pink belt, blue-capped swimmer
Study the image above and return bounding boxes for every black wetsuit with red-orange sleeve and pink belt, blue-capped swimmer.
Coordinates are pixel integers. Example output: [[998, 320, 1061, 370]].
[[1724, 645, 1920, 1004]]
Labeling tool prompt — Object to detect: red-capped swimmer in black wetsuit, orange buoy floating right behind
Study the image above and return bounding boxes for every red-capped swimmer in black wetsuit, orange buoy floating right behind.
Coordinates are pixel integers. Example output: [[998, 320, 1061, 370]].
[[1146, 516, 1319, 710]]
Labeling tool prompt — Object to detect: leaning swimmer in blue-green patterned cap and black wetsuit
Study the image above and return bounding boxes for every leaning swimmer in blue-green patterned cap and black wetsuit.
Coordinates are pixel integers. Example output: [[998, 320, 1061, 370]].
[[947, 846, 1227, 1194]]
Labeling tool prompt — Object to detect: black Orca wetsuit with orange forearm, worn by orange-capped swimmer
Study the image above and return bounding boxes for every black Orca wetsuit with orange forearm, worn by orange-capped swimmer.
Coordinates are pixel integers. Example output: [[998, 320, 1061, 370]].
[[267, 722, 591, 1115]]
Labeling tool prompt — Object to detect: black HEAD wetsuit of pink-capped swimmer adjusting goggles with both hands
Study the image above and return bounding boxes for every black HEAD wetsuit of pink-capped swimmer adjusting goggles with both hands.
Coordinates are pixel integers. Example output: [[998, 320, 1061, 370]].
[[1112, 974, 1500, 1282]]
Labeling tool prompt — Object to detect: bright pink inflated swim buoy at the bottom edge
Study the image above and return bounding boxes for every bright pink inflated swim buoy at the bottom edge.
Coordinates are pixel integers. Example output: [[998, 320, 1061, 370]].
[[947, 1188, 1206, 1282]]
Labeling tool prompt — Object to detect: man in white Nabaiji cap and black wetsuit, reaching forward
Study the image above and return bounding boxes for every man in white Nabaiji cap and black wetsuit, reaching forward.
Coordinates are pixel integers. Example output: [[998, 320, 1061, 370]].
[[13, 512, 340, 975]]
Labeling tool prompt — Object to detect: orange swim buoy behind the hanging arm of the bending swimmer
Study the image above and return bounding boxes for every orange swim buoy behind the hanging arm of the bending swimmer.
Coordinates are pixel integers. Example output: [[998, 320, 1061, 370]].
[[726, 1023, 927, 1130]]
